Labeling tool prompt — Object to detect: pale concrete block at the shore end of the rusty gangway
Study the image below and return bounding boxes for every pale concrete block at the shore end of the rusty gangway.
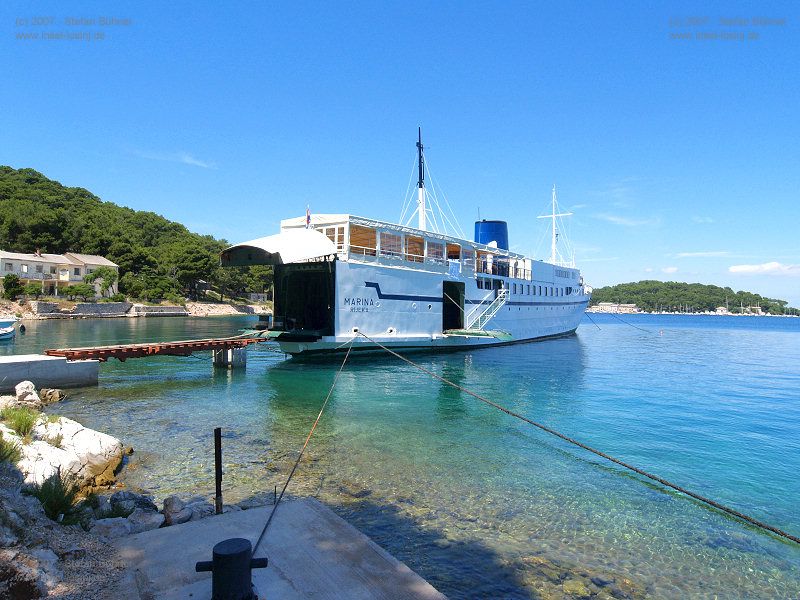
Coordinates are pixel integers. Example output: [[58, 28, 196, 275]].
[[0, 354, 100, 392]]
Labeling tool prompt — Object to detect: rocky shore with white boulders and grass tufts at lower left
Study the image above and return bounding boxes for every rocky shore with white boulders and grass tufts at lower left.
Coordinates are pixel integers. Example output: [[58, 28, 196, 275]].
[[0, 381, 282, 599]]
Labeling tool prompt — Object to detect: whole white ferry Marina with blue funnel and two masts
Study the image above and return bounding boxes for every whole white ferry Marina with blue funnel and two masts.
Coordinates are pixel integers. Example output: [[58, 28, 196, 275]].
[[222, 130, 591, 355]]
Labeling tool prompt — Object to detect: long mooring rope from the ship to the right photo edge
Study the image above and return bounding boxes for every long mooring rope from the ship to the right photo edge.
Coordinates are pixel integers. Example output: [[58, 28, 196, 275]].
[[359, 331, 800, 544]]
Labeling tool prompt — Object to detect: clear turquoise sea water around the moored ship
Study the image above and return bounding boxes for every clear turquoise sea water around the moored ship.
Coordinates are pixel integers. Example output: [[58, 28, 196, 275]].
[[0, 315, 800, 598]]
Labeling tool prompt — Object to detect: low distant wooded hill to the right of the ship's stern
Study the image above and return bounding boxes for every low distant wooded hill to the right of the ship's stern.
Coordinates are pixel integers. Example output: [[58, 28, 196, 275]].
[[591, 280, 798, 315]]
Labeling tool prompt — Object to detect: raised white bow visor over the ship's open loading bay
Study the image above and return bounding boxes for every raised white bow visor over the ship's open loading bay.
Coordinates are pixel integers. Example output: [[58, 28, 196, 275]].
[[221, 229, 336, 267]]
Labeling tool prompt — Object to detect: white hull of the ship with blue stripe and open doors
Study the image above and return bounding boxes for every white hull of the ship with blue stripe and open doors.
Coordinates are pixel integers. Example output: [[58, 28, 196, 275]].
[[275, 260, 590, 356]]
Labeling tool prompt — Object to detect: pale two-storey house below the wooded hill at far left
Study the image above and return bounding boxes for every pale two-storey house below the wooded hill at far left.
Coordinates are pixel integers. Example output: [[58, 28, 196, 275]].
[[0, 250, 119, 296]]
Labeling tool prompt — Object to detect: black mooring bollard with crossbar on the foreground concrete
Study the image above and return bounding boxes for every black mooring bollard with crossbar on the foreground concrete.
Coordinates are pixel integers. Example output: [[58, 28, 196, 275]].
[[194, 538, 268, 600]]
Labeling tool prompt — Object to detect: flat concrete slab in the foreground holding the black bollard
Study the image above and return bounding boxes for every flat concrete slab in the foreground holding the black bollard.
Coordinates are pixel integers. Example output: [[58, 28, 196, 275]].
[[116, 498, 446, 600]]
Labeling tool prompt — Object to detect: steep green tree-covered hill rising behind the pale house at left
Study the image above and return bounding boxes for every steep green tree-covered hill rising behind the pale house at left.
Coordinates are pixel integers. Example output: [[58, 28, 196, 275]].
[[0, 166, 272, 300]]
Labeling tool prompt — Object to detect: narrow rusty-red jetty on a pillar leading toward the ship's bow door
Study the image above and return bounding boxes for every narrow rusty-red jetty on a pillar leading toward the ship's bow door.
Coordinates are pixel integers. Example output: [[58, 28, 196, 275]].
[[44, 337, 267, 366]]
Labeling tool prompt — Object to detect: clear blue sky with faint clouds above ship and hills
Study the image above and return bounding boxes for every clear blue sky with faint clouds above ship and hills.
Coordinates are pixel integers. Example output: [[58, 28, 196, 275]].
[[0, 1, 800, 306]]
